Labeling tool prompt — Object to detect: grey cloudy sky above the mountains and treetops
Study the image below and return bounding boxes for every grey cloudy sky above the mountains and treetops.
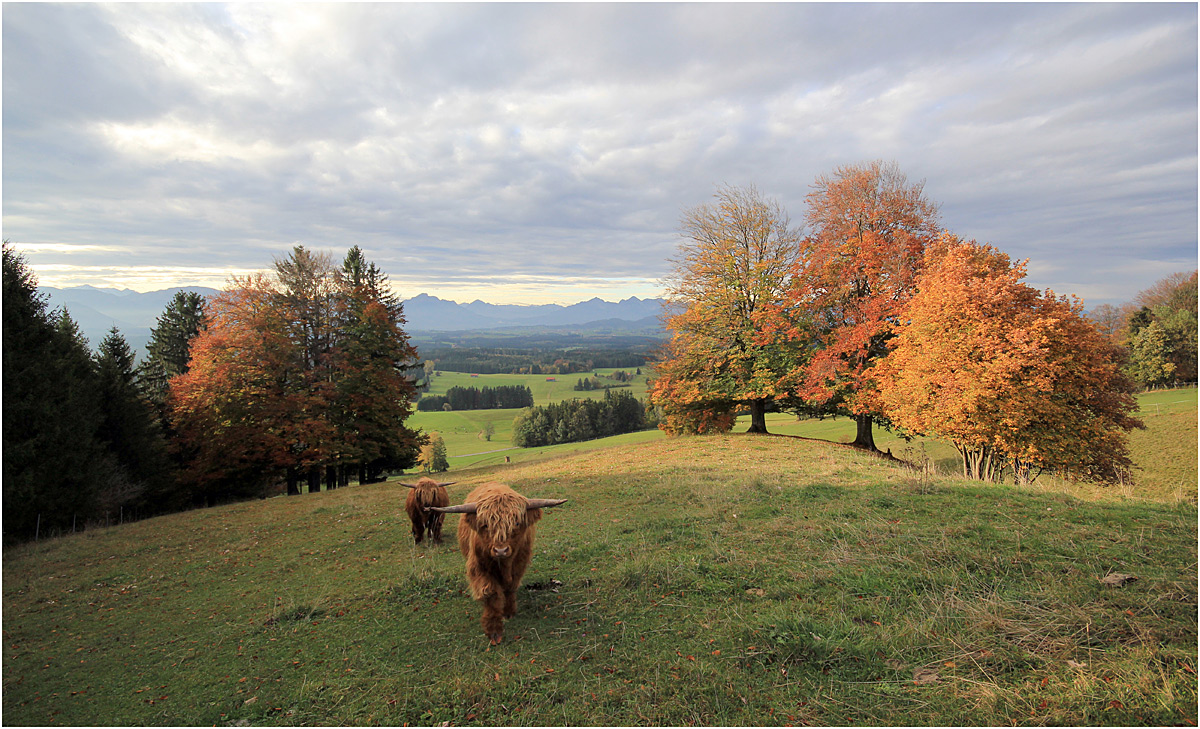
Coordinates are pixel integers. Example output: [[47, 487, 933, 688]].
[[2, 2, 1198, 306]]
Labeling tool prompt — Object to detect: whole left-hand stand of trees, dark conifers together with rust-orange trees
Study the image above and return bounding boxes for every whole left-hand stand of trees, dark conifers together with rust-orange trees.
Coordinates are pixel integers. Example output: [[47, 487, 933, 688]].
[[4, 241, 424, 542]]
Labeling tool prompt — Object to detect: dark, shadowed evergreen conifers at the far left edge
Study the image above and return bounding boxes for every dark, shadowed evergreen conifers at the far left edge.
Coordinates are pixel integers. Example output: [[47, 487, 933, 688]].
[[4, 241, 176, 543]]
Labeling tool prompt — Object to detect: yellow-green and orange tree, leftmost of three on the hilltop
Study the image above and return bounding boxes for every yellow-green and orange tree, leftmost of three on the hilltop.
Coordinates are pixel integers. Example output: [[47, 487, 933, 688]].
[[650, 186, 804, 434]]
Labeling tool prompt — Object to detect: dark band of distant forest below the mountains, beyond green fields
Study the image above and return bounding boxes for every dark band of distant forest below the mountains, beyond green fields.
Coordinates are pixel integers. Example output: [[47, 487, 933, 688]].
[[420, 348, 652, 374]]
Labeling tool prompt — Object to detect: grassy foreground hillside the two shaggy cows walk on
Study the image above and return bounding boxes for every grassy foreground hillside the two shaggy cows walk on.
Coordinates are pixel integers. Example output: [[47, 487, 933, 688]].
[[2, 435, 1196, 725]]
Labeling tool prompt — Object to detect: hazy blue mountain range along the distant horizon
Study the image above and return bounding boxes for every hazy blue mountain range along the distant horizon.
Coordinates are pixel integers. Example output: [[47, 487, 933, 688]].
[[37, 285, 664, 355]]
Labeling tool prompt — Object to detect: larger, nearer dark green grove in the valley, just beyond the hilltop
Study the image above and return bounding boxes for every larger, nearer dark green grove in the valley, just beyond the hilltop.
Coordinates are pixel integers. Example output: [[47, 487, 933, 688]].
[[512, 390, 654, 448]]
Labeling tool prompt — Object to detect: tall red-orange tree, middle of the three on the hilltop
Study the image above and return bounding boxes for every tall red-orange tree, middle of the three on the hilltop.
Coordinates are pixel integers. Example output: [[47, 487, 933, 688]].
[[792, 161, 938, 451]]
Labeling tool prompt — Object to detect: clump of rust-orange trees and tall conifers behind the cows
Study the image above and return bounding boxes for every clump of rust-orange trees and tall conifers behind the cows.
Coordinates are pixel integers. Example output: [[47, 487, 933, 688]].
[[168, 246, 422, 500]]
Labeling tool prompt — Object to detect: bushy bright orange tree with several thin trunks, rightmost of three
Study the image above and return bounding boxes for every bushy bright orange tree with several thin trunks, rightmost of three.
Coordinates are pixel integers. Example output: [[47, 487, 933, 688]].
[[871, 233, 1141, 482]]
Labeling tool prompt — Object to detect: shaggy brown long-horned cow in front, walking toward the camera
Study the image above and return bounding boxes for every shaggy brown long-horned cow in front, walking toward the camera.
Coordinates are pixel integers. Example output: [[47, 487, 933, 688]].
[[433, 483, 566, 645]]
